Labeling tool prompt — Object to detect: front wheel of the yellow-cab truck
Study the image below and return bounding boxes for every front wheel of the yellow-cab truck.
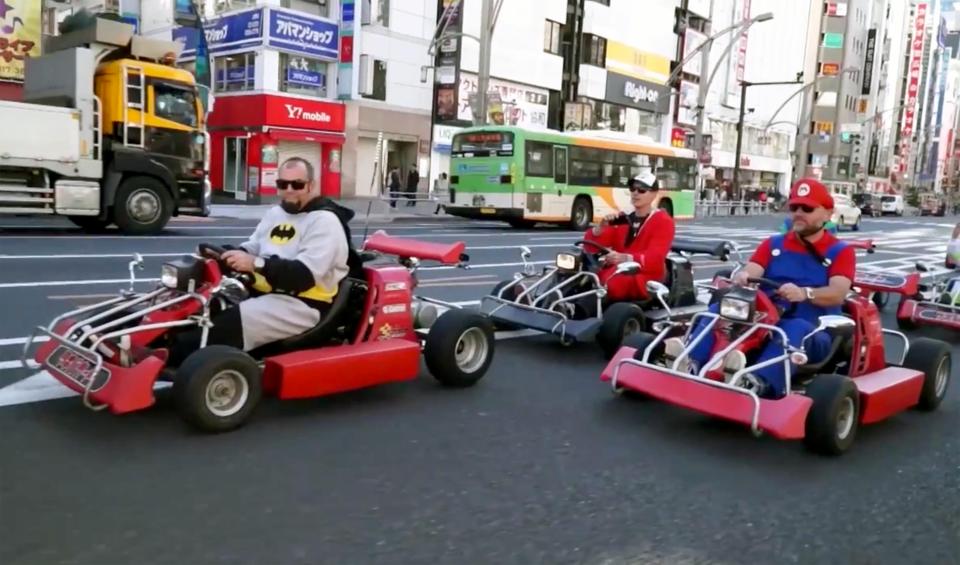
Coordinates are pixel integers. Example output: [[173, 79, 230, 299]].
[[113, 176, 173, 235]]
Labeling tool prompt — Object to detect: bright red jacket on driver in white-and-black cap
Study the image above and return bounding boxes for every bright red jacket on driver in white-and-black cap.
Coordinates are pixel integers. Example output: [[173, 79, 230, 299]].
[[584, 208, 676, 282]]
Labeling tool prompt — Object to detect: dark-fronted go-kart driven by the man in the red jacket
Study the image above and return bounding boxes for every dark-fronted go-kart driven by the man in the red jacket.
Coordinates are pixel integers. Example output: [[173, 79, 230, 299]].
[[480, 241, 735, 358]]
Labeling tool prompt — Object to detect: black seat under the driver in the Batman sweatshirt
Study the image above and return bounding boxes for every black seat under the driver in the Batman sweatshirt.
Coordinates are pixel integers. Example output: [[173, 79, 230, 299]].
[[252, 277, 367, 357]]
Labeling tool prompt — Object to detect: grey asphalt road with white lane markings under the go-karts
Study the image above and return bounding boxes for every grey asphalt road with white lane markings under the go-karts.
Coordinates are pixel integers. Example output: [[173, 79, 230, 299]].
[[0, 213, 960, 565]]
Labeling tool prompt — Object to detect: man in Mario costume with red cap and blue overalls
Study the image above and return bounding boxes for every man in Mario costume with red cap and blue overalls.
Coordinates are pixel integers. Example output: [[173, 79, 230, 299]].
[[665, 178, 857, 398]]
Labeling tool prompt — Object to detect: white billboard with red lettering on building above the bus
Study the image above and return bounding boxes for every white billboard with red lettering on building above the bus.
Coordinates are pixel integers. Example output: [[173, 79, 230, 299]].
[[457, 73, 550, 129]]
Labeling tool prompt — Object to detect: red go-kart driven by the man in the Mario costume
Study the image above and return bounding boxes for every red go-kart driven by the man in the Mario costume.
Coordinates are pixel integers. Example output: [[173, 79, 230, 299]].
[[601, 270, 952, 454]]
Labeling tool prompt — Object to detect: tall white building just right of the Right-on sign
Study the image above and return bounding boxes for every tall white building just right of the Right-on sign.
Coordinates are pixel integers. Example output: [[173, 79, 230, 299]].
[[675, 0, 808, 199]]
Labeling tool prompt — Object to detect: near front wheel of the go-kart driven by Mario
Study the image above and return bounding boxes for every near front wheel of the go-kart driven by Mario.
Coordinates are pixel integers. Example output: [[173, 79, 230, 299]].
[[803, 375, 860, 455]]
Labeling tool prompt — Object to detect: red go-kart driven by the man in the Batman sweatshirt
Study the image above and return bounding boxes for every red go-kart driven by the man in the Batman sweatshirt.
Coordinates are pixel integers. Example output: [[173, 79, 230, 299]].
[[24, 232, 494, 432]]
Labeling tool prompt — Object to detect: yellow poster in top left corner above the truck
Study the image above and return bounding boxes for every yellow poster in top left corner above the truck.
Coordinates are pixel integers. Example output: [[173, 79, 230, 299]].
[[0, 0, 41, 81]]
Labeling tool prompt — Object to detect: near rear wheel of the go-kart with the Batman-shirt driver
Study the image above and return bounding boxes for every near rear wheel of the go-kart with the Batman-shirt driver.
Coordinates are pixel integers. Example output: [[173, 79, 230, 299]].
[[423, 310, 495, 388]]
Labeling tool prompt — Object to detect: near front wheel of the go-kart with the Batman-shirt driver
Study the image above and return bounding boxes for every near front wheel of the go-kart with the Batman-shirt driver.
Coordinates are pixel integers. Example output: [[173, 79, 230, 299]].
[[173, 345, 262, 432]]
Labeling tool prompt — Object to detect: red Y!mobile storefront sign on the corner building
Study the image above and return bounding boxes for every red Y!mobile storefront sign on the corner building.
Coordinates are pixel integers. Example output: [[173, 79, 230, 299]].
[[209, 94, 346, 132]]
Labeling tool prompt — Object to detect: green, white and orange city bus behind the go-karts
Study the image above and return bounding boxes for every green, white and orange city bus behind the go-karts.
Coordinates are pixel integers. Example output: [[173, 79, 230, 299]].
[[446, 126, 697, 230]]
